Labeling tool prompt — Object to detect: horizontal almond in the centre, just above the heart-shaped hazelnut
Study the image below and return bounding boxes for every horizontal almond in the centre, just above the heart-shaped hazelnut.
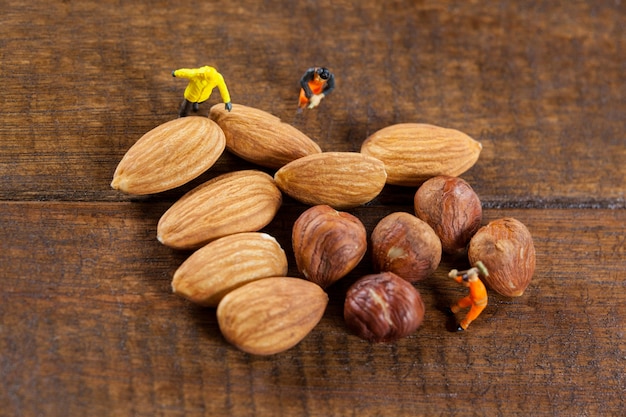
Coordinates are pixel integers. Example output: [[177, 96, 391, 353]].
[[274, 152, 387, 209]]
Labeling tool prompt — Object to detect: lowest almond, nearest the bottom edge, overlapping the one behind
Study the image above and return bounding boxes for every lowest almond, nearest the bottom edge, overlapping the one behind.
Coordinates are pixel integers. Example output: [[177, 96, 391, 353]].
[[217, 277, 328, 355]]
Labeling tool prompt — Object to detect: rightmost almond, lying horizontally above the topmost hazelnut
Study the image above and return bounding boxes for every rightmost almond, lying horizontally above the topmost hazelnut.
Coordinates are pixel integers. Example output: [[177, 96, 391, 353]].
[[361, 123, 482, 186]]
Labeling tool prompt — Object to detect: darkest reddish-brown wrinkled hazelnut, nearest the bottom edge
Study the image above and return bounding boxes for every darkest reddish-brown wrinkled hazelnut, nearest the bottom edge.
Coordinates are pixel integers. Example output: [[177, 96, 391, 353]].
[[343, 272, 425, 342]]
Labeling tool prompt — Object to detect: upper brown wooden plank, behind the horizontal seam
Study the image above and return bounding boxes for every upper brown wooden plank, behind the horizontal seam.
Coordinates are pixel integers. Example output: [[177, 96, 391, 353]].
[[0, 1, 626, 208]]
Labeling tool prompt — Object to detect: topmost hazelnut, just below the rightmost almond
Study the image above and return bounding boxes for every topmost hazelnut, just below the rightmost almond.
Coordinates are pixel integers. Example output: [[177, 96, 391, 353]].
[[414, 175, 483, 255]]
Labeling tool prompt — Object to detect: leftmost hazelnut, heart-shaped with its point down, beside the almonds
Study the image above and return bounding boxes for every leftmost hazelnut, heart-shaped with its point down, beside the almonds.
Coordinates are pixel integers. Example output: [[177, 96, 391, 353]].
[[291, 205, 367, 288]]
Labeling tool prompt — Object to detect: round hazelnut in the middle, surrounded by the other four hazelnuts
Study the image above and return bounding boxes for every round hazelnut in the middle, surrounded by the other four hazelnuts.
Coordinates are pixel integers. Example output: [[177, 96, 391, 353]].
[[371, 212, 441, 282]]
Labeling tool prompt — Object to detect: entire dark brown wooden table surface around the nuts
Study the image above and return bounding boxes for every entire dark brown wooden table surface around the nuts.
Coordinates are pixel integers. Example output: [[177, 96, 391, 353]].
[[0, 0, 626, 417]]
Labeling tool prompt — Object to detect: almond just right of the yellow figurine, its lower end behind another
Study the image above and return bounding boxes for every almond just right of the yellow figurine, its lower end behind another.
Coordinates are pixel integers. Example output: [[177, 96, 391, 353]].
[[209, 104, 322, 169]]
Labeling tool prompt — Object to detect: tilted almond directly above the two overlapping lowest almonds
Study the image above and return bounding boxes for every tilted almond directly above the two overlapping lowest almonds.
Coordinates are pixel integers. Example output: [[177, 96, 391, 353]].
[[157, 170, 282, 249]]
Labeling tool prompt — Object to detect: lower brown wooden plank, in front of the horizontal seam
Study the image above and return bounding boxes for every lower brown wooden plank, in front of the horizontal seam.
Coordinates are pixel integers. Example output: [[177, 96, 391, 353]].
[[0, 202, 626, 416]]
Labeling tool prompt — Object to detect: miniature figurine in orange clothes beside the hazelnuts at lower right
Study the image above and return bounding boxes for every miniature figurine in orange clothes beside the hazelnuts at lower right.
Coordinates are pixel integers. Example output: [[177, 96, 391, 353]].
[[448, 261, 489, 331]]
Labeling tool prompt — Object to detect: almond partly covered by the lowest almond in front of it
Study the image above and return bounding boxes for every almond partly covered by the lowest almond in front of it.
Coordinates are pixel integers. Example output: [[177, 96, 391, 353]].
[[172, 232, 287, 307]]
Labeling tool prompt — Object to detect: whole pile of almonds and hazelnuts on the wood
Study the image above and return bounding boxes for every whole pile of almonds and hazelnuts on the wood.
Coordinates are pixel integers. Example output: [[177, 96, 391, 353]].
[[111, 105, 535, 355]]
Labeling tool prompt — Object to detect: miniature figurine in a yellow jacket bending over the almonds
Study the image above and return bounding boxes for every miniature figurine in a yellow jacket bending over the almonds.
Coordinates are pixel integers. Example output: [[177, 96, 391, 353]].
[[172, 66, 233, 117]]
